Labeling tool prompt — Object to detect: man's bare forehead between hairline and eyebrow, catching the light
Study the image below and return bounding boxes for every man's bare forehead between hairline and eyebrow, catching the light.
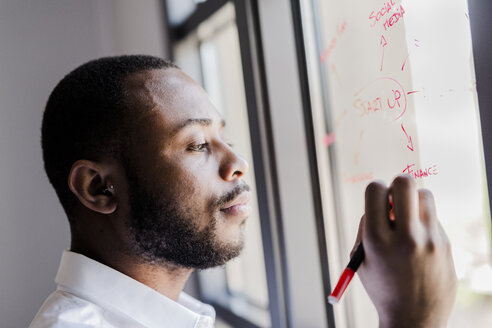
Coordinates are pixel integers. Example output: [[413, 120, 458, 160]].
[[125, 68, 221, 132]]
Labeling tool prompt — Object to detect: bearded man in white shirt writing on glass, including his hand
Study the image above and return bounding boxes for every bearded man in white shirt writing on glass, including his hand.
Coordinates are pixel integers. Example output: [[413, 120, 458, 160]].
[[31, 56, 456, 328]]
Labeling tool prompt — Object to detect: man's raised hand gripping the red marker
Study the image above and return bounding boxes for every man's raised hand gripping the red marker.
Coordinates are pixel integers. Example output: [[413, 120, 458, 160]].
[[355, 176, 456, 328]]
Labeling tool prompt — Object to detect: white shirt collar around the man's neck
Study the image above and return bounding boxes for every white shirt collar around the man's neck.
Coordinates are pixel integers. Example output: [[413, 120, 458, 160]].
[[55, 251, 215, 328]]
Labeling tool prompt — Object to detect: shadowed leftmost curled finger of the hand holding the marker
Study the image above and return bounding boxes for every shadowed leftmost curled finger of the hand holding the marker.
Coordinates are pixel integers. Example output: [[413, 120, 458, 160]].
[[365, 182, 391, 241]]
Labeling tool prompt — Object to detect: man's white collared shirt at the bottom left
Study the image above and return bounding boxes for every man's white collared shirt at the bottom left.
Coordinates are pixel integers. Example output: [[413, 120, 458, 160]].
[[29, 251, 215, 328]]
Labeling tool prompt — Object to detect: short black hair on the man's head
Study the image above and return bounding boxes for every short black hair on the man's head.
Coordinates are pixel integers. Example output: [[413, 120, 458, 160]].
[[41, 55, 178, 219]]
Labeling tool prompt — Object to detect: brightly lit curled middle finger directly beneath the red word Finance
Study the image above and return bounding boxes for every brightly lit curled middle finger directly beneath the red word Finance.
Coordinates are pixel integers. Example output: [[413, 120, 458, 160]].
[[389, 175, 420, 237]]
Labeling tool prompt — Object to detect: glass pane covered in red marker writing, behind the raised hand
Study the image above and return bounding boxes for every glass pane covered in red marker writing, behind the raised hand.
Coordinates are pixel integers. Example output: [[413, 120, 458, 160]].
[[301, 0, 492, 327]]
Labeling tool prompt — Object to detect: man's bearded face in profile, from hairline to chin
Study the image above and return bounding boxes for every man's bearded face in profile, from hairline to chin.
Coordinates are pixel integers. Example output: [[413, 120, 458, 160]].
[[119, 68, 250, 268]]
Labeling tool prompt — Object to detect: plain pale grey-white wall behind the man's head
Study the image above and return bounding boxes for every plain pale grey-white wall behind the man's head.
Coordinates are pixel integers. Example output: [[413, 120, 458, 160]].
[[0, 0, 166, 328]]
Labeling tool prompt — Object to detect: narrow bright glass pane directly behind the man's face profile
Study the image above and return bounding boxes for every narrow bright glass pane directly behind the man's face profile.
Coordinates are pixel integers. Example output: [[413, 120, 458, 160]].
[[199, 5, 268, 308]]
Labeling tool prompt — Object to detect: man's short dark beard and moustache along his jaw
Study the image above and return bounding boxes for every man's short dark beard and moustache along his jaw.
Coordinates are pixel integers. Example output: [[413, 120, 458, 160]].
[[127, 167, 249, 269]]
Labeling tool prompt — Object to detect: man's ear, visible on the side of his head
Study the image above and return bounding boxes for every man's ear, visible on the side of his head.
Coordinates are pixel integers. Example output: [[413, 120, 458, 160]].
[[68, 160, 118, 214]]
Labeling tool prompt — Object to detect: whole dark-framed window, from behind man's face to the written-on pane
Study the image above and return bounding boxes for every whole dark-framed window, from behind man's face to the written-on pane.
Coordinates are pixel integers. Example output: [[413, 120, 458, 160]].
[[166, 0, 492, 328]]
